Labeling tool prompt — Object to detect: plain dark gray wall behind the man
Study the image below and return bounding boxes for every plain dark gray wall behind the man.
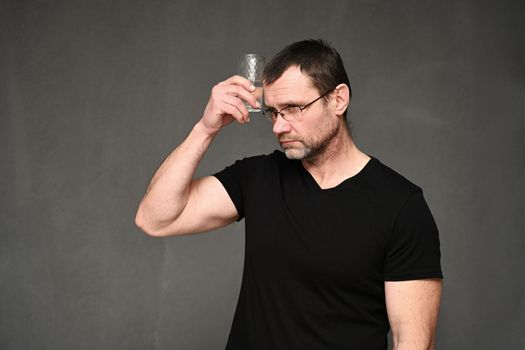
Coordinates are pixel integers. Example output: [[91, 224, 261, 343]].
[[0, 0, 525, 349]]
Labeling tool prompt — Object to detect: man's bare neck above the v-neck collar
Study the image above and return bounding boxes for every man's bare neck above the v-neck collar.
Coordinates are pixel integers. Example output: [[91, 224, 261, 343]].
[[302, 125, 370, 189]]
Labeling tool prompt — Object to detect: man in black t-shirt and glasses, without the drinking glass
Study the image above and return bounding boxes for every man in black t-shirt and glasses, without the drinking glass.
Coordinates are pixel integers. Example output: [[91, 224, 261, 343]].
[[136, 40, 442, 350]]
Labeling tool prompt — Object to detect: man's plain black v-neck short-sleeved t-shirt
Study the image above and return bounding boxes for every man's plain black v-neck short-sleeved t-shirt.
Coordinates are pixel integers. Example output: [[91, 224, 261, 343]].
[[214, 151, 442, 350]]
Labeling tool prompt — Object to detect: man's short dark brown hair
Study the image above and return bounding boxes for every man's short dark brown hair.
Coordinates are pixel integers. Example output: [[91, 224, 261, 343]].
[[263, 39, 352, 120]]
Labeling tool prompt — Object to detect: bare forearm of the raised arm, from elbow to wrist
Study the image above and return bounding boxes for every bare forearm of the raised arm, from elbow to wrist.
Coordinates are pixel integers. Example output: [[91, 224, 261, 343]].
[[135, 123, 214, 231]]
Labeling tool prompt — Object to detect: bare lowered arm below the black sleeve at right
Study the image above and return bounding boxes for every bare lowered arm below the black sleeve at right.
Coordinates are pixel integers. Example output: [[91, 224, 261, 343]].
[[385, 278, 442, 349]]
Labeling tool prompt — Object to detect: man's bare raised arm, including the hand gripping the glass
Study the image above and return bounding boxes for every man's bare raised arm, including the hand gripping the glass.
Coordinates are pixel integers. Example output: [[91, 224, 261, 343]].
[[135, 76, 257, 237]]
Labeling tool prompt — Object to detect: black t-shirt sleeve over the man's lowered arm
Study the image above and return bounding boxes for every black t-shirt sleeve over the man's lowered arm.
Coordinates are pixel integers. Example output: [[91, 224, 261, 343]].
[[384, 191, 443, 281]]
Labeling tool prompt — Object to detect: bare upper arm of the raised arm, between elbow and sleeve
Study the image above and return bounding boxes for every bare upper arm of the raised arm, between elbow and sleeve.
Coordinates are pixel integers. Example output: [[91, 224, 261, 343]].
[[159, 176, 239, 236]]
